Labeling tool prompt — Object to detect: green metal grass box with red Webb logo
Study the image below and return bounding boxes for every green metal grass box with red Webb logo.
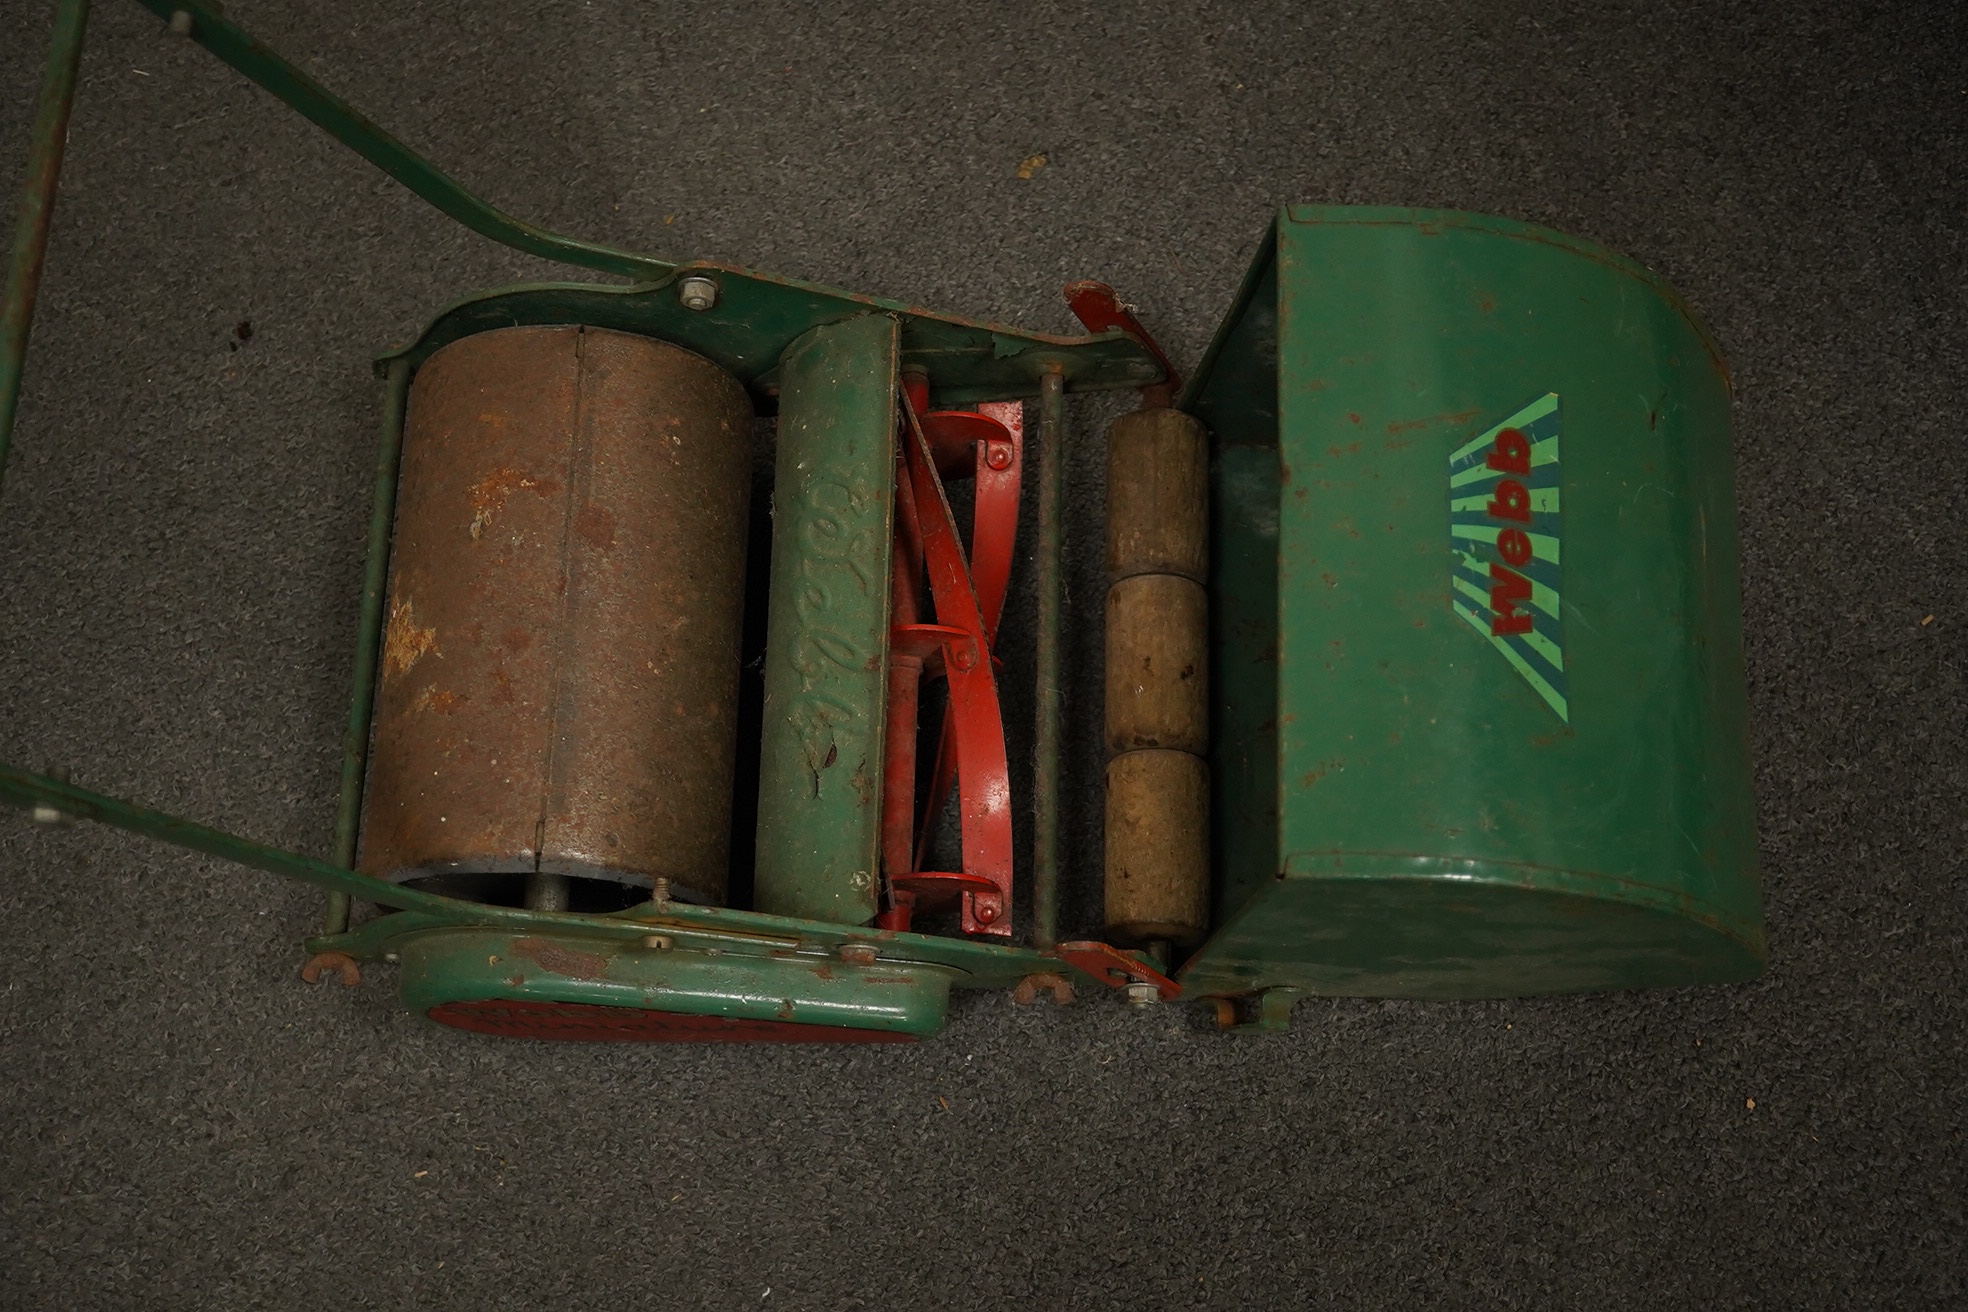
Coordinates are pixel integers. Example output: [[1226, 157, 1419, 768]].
[[1183, 209, 1763, 997]]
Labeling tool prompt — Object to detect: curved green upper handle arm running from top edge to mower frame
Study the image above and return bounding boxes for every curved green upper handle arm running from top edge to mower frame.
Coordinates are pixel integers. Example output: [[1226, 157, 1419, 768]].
[[138, 0, 677, 281]]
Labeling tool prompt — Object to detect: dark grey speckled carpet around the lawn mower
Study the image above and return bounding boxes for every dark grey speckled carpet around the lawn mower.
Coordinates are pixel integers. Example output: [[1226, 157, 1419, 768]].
[[0, 0, 1968, 1310]]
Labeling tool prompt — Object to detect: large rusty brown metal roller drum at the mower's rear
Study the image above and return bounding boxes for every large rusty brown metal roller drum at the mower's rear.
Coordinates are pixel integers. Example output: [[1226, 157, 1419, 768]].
[[358, 327, 752, 909]]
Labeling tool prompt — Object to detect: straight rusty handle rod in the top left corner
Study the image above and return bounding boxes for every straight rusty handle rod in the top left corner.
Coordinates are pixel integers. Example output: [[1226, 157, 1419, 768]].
[[0, 0, 89, 497]]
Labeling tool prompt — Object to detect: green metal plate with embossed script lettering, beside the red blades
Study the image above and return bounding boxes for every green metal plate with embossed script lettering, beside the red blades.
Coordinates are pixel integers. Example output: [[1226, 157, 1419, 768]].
[[754, 315, 899, 924]]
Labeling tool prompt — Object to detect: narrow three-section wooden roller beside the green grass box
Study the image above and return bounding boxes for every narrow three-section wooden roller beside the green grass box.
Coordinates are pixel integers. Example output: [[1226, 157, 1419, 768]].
[[1106, 409, 1210, 944]]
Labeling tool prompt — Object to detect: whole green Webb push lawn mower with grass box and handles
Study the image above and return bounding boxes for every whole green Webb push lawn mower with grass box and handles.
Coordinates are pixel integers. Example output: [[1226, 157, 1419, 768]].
[[0, 0, 1763, 1041]]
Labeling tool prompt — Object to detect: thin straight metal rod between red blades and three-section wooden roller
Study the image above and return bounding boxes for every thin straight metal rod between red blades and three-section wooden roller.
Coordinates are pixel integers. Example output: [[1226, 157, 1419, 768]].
[[1031, 368, 1067, 950]]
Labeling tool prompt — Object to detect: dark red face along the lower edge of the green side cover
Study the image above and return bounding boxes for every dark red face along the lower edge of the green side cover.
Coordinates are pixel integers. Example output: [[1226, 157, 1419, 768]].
[[429, 999, 915, 1043]]
